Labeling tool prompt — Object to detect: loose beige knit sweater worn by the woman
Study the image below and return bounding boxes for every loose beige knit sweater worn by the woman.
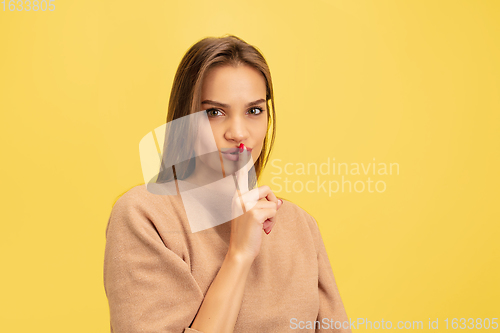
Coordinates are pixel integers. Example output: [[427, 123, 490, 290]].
[[104, 185, 350, 333]]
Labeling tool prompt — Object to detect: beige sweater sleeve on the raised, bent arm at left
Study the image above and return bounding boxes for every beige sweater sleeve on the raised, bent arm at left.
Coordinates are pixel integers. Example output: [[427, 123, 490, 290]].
[[104, 194, 203, 333]]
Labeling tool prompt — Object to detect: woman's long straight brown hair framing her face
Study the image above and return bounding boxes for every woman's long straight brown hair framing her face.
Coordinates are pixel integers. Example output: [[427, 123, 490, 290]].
[[157, 35, 276, 188]]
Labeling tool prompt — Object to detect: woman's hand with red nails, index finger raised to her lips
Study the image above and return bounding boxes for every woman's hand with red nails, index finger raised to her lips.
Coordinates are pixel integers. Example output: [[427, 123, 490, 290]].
[[228, 149, 283, 260]]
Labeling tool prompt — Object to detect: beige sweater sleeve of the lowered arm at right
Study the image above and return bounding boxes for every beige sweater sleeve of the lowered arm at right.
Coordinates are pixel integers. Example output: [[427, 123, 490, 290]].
[[304, 216, 351, 332]]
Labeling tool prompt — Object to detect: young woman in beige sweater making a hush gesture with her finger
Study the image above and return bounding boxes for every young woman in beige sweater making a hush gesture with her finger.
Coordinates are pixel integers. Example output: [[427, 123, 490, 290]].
[[104, 35, 350, 333]]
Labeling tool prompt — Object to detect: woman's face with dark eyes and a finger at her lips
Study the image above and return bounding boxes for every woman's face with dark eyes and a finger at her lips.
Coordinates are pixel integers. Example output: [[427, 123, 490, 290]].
[[195, 65, 268, 176]]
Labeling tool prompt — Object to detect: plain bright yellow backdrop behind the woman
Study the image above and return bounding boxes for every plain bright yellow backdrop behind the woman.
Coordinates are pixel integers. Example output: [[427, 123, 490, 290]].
[[0, 0, 500, 333]]
